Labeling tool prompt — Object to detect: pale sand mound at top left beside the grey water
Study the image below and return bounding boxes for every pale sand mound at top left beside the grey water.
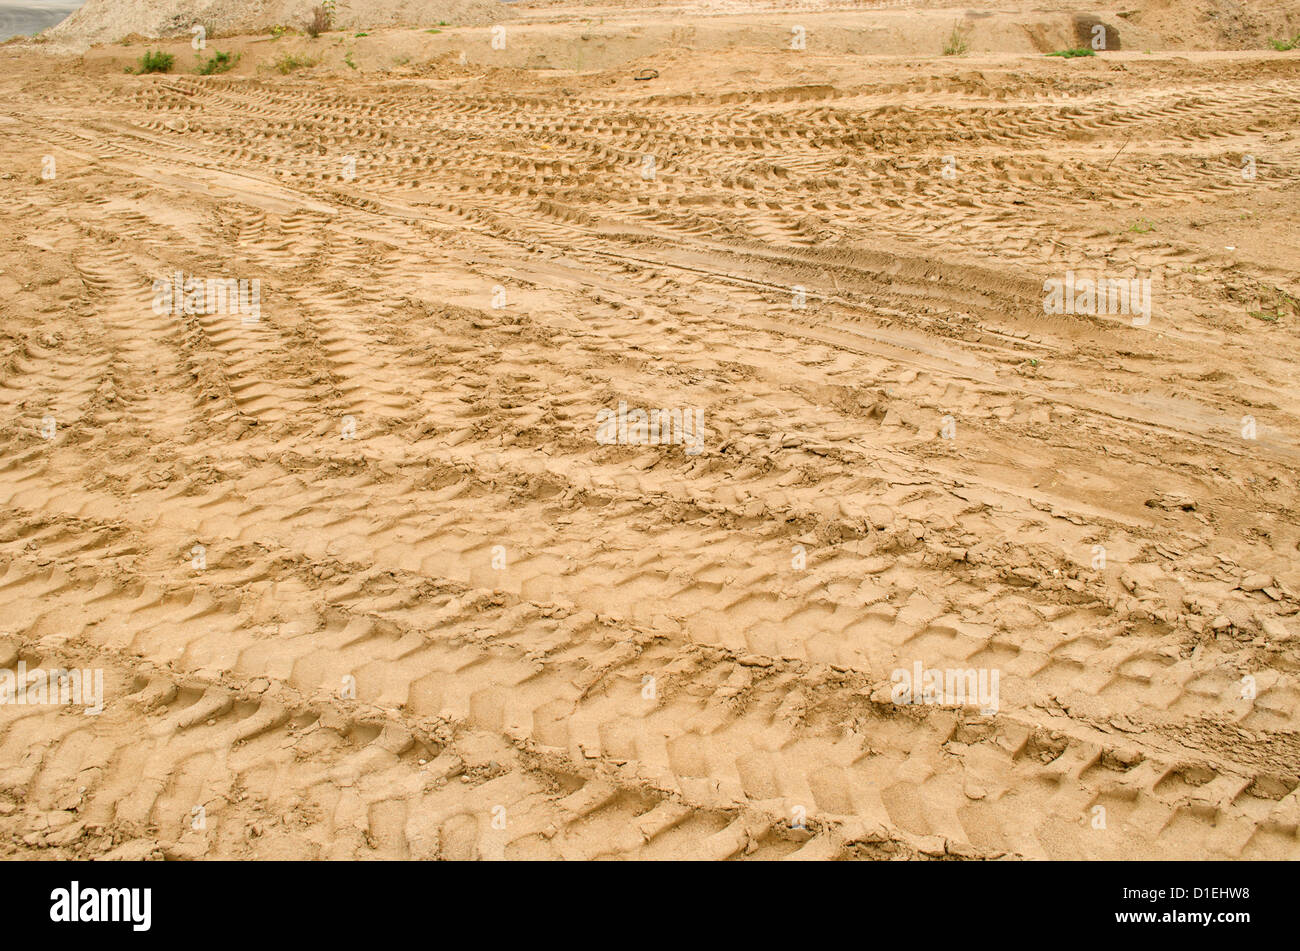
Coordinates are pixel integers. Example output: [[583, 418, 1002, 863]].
[[46, 0, 510, 45]]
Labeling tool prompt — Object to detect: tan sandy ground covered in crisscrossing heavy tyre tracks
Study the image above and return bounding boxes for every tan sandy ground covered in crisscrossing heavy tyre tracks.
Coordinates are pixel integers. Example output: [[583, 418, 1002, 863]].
[[0, 4, 1300, 859]]
